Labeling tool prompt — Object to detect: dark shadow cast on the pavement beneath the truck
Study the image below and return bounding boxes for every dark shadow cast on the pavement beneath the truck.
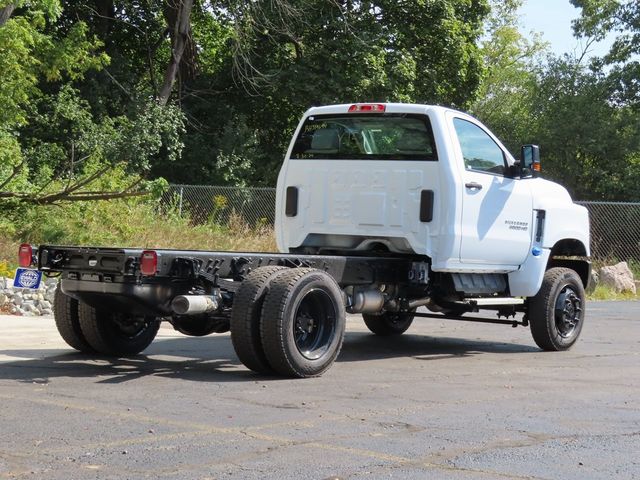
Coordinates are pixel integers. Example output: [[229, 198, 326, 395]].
[[0, 332, 539, 384]]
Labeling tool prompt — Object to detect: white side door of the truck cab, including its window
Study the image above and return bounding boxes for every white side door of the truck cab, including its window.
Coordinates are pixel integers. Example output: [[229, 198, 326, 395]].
[[452, 116, 533, 266]]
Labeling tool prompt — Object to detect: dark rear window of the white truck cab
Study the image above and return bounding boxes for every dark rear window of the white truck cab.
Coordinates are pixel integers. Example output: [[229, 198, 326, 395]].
[[291, 114, 437, 161]]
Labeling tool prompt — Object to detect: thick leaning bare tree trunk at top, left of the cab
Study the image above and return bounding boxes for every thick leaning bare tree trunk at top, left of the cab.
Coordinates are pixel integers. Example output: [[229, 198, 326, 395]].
[[158, 0, 193, 105]]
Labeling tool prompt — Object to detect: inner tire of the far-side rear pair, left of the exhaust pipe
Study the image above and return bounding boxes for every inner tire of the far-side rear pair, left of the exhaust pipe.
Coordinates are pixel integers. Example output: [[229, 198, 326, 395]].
[[78, 303, 160, 357]]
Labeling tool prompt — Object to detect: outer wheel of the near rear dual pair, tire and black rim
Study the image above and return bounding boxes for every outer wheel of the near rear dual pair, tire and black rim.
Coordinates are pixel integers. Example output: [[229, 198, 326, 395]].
[[260, 268, 346, 378]]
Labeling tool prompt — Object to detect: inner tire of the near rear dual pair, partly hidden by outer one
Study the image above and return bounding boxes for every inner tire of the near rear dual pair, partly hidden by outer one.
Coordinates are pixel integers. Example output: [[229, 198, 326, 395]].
[[231, 266, 286, 374]]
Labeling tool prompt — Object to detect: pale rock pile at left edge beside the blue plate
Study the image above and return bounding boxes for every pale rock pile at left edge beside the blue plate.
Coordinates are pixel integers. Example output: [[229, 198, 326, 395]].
[[0, 277, 58, 317]]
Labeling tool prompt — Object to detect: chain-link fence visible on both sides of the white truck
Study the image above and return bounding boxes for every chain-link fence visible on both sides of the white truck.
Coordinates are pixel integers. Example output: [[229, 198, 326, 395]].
[[162, 185, 640, 263]]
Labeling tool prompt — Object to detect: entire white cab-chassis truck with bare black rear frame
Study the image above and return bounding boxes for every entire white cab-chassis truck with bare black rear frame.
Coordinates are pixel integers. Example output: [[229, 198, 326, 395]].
[[19, 103, 591, 377]]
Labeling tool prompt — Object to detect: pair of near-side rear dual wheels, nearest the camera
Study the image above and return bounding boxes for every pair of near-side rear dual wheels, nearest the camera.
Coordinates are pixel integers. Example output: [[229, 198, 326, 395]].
[[231, 266, 346, 377]]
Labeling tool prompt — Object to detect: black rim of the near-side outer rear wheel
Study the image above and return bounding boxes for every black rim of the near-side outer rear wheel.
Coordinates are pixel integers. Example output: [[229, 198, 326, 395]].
[[293, 289, 337, 360]]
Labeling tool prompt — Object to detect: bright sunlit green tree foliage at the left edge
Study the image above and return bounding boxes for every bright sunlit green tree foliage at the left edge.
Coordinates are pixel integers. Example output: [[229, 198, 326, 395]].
[[0, 0, 182, 208]]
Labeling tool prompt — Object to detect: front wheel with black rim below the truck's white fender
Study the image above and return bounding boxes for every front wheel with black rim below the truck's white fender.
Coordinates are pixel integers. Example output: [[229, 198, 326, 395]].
[[528, 268, 585, 352]]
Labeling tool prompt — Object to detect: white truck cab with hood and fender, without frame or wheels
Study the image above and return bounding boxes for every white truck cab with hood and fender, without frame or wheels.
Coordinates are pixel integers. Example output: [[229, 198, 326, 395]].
[[276, 103, 589, 296]]
